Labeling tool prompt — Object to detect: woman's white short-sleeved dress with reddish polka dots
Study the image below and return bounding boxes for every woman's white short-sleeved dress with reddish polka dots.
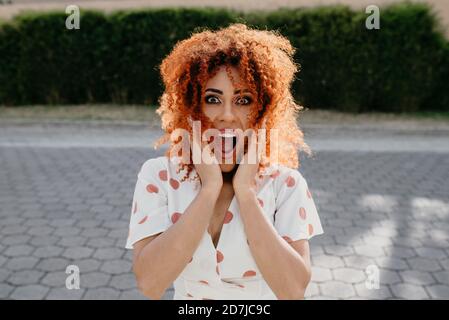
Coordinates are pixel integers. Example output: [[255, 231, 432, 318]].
[[126, 157, 323, 300]]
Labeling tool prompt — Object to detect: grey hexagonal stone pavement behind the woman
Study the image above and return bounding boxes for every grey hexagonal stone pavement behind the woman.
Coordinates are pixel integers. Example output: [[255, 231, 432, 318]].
[[0, 123, 449, 299]]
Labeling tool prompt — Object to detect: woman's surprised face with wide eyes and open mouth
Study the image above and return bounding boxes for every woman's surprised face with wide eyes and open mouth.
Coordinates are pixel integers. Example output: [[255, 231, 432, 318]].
[[202, 66, 254, 172]]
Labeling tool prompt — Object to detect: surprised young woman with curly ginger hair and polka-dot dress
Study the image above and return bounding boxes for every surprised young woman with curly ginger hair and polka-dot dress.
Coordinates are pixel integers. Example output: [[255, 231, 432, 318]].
[[126, 24, 323, 300]]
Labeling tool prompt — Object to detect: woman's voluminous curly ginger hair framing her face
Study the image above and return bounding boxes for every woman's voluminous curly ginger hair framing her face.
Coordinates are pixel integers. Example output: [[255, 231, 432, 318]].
[[155, 23, 311, 179]]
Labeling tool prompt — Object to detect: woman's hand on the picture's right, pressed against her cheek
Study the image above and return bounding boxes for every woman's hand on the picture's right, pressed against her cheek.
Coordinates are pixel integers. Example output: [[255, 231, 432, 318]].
[[232, 134, 259, 193]]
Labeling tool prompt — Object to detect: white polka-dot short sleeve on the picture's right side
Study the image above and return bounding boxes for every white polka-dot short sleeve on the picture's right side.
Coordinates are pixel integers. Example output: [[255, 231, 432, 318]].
[[274, 168, 324, 242]]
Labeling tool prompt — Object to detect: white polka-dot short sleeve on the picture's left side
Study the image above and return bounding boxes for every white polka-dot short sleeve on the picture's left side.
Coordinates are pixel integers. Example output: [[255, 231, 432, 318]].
[[125, 158, 172, 249]]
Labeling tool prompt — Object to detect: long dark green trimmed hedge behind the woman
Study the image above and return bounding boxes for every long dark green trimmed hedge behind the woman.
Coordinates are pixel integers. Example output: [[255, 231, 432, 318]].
[[0, 3, 449, 112]]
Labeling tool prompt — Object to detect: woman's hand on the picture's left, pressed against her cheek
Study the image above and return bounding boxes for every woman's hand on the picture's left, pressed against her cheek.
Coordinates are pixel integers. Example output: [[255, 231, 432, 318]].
[[192, 134, 223, 195]]
